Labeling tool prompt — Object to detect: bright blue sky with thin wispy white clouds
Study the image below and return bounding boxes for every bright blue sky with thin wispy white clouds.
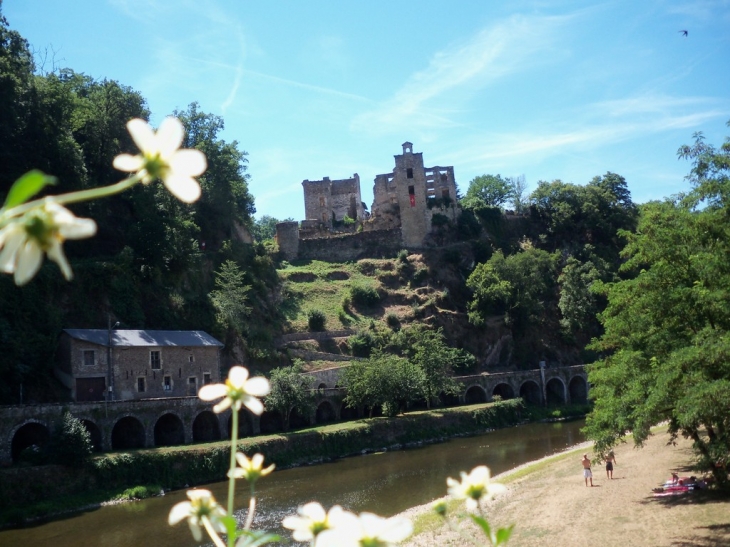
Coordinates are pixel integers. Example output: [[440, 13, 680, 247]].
[[2, 0, 730, 220]]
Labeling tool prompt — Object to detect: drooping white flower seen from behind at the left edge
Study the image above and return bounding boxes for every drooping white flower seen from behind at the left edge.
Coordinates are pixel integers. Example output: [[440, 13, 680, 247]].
[[0, 199, 96, 286]]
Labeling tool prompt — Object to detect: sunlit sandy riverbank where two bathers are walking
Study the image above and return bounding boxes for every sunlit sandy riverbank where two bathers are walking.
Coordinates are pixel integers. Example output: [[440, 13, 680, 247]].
[[400, 432, 730, 547]]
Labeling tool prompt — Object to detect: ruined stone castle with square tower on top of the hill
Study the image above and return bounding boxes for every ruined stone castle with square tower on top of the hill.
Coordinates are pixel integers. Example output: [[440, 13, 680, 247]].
[[276, 142, 459, 260]]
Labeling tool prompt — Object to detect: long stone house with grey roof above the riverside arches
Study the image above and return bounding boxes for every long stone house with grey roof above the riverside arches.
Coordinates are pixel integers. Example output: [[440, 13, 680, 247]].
[[54, 329, 223, 401]]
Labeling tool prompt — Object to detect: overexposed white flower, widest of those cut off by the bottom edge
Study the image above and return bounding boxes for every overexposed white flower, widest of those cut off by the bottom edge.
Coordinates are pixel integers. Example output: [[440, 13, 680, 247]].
[[316, 511, 413, 547]]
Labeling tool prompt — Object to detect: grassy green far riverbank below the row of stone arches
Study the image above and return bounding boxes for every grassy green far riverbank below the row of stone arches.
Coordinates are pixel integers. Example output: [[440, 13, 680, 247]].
[[0, 399, 587, 527]]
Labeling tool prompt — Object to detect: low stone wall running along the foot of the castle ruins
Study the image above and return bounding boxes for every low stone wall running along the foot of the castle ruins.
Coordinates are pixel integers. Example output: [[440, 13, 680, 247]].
[[299, 228, 402, 262]]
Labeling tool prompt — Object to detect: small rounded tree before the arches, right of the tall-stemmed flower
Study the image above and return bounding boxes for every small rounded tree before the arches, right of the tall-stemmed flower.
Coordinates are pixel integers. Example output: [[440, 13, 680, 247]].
[[264, 363, 314, 431]]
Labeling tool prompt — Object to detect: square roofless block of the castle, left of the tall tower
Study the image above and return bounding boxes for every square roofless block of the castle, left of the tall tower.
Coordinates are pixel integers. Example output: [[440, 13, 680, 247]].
[[302, 173, 365, 227]]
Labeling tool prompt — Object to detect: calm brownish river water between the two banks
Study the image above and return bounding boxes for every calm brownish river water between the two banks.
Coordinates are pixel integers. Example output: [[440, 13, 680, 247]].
[[0, 420, 584, 547]]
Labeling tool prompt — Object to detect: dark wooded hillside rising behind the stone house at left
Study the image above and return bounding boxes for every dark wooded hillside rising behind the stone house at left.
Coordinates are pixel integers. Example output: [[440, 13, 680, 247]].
[[0, 10, 277, 404]]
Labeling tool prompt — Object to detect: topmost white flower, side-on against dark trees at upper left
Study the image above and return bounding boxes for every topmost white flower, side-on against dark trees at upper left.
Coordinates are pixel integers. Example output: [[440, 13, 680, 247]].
[[113, 117, 208, 203]]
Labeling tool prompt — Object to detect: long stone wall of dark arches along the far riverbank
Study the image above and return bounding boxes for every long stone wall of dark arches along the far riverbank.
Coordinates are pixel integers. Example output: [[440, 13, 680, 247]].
[[0, 366, 588, 463]]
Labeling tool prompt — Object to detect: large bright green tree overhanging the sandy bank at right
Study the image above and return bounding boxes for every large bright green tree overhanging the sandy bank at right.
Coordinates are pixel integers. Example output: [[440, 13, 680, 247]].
[[586, 125, 730, 484]]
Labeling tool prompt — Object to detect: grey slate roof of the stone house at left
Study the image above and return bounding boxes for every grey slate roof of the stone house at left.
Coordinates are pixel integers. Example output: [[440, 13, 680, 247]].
[[63, 329, 223, 347]]
